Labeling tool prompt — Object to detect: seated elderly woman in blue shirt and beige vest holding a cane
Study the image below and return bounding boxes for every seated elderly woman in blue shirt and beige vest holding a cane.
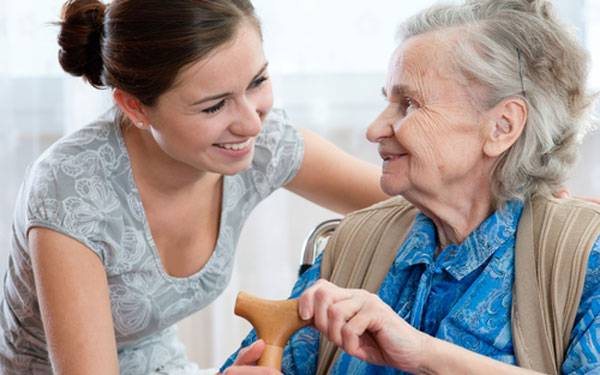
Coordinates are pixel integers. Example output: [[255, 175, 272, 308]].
[[221, 0, 600, 374]]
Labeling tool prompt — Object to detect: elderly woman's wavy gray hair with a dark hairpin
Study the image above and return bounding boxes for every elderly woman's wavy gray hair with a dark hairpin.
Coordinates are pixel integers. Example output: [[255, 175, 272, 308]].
[[399, 0, 594, 205]]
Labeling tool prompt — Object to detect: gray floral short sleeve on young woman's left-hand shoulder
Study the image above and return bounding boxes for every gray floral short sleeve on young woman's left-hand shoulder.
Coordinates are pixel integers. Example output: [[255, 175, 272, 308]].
[[18, 133, 121, 261]]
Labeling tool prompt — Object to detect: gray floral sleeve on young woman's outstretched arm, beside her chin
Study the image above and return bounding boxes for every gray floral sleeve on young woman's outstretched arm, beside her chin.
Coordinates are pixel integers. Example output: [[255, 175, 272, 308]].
[[251, 109, 304, 198]]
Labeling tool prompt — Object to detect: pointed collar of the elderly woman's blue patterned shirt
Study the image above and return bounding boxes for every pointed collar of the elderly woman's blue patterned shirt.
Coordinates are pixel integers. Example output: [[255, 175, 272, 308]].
[[393, 200, 523, 280]]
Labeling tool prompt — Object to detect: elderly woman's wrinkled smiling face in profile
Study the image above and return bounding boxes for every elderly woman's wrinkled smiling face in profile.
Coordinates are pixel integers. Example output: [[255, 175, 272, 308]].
[[367, 34, 492, 196]]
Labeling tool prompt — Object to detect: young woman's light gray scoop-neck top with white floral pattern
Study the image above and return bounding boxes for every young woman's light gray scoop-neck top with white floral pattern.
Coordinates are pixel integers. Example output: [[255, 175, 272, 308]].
[[0, 110, 304, 375]]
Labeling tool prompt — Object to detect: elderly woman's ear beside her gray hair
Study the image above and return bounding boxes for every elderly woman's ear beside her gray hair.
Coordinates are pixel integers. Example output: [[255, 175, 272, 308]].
[[483, 97, 527, 158]]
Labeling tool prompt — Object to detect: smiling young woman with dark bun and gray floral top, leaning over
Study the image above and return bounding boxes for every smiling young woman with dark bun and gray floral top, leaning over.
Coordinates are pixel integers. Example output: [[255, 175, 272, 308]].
[[0, 0, 385, 375]]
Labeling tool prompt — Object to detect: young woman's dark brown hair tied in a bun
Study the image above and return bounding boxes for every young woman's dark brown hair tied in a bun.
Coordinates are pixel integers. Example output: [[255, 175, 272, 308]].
[[58, 0, 260, 106]]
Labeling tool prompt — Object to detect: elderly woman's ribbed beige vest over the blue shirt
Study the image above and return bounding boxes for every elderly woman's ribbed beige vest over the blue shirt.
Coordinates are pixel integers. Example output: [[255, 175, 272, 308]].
[[317, 197, 600, 375]]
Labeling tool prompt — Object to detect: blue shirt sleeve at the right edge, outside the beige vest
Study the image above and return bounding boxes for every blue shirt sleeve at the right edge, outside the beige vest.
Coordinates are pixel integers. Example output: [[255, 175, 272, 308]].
[[561, 238, 600, 374]]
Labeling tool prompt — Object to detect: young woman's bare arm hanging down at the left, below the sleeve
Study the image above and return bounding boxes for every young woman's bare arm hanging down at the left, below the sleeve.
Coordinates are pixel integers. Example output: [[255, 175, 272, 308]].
[[29, 228, 119, 375]]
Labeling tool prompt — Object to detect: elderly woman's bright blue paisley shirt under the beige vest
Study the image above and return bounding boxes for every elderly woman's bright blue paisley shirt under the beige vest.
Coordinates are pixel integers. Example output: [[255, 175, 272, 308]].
[[223, 202, 600, 374]]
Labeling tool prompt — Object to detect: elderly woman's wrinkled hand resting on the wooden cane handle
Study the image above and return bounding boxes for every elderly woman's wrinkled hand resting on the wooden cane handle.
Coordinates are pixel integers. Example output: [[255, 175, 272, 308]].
[[298, 280, 428, 372]]
